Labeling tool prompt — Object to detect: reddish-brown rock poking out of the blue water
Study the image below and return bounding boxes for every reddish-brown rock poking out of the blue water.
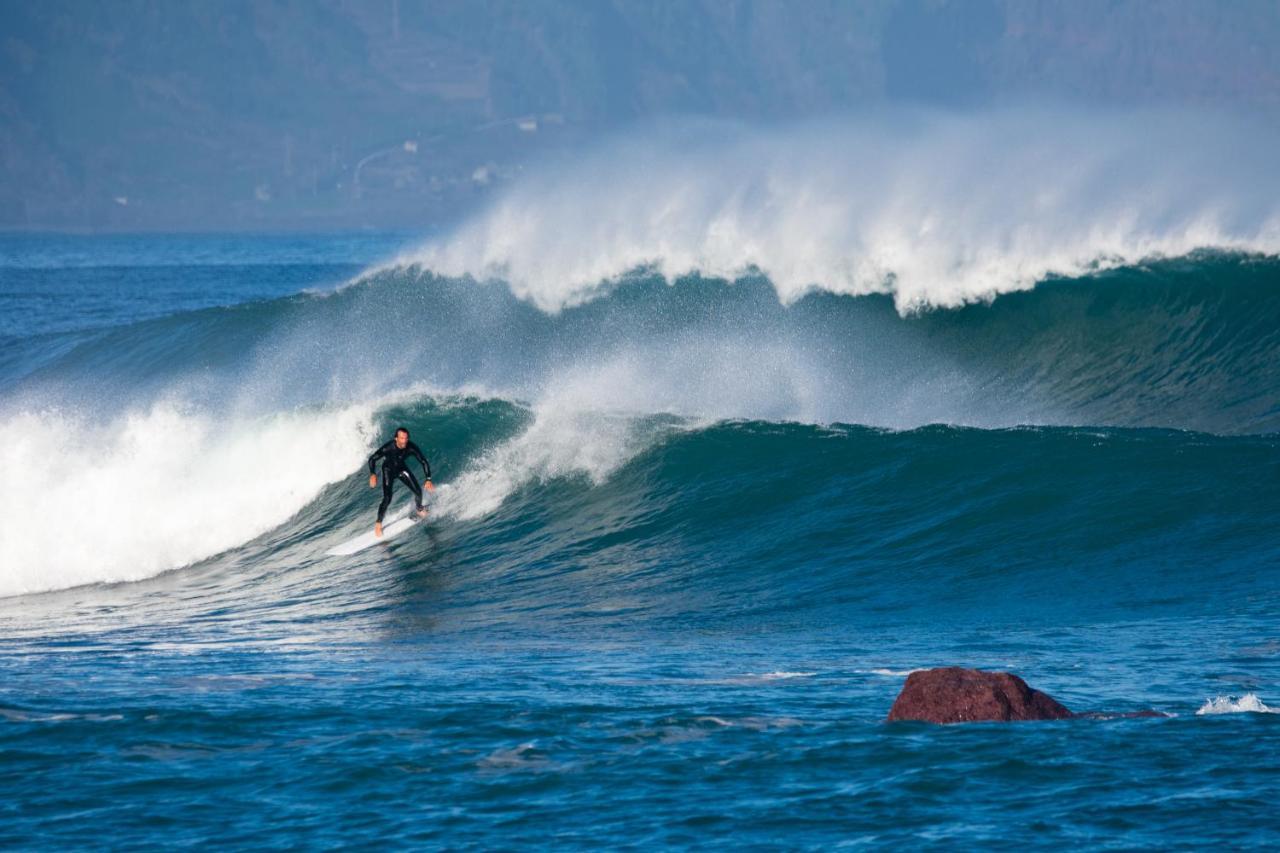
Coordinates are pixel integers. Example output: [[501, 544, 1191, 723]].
[[888, 666, 1075, 722]]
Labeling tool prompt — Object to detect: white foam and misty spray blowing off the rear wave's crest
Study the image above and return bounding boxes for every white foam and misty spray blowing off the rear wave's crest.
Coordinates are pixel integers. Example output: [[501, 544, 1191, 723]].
[[397, 109, 1280, 313]]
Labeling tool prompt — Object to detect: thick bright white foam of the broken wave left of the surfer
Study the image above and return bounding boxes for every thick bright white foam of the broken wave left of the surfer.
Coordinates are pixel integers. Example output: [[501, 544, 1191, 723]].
[[0, 402, 371, 596]]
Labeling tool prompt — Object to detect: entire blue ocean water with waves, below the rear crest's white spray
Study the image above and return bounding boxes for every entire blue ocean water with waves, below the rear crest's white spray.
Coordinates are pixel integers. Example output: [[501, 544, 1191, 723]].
[[0, 234, 1280, 849]]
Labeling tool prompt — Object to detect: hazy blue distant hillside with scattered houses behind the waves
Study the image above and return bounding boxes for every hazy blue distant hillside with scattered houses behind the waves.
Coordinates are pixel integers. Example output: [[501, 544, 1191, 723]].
[[0, 0, 1280, 229]]
